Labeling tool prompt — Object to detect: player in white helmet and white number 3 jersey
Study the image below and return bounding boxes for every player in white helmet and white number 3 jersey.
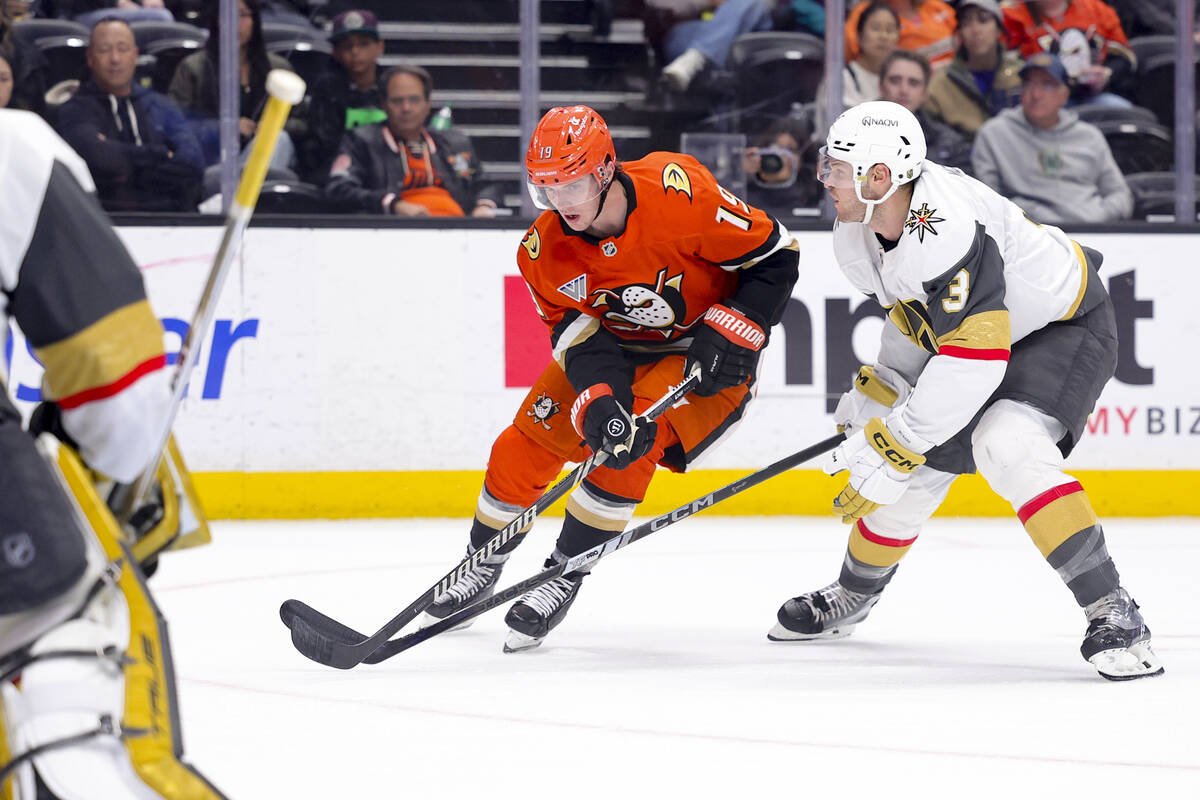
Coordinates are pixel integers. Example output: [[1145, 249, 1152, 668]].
[[768, 101, 1163, 680]]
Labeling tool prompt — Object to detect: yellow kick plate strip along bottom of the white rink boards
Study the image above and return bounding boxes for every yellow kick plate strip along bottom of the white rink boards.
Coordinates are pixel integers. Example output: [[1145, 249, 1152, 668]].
[[193, 469, 1200, 521]]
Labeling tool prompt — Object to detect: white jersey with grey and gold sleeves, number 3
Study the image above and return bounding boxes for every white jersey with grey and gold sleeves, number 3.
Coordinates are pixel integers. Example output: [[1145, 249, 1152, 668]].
[[833, 161, 1103, 452]]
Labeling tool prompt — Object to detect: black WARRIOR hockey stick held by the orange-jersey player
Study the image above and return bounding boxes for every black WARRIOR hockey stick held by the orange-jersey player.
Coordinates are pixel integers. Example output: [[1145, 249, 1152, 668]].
[[280, 369, 700, 669]]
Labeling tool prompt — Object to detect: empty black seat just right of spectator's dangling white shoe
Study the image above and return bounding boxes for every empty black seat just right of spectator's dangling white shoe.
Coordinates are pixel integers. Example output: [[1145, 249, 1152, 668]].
[[727, 31, 824, 115]]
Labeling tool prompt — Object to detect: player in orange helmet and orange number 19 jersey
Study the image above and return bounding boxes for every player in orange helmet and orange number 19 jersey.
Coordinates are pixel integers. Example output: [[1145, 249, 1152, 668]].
[[425, 106, 799, 652]]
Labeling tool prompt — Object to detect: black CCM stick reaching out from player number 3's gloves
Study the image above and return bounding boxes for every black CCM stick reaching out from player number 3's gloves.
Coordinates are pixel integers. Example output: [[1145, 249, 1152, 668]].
[[360, 433, 846, 664]]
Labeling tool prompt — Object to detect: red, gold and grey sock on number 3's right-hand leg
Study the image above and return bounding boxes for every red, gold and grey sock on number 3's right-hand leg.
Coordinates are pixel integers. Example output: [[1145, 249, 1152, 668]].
[[1016, 481, 1121, 606]]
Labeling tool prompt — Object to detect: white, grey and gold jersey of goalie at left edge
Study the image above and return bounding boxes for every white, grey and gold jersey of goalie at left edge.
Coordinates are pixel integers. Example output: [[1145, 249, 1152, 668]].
[[0, 109, 170, 481]]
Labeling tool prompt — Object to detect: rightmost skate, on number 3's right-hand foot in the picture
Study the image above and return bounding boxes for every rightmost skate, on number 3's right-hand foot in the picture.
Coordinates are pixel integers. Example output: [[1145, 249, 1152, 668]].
[[1079, 588, 1164, 680]]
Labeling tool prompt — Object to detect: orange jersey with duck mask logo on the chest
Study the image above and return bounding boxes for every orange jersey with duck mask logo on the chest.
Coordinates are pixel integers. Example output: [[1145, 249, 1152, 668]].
[[517, 152, 781, 344]]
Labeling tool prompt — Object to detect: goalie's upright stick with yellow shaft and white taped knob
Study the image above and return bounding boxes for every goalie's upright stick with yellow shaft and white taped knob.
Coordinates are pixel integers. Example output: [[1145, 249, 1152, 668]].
[[108, 70, 306, 523]]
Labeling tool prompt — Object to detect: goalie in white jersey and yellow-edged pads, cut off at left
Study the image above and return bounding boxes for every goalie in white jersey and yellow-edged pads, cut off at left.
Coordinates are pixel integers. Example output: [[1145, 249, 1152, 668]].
[[0, 109, 222, 800]]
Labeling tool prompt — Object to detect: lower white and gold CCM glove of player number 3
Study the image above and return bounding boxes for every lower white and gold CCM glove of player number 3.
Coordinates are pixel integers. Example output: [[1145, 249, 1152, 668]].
[[823, 417, 925, 523]]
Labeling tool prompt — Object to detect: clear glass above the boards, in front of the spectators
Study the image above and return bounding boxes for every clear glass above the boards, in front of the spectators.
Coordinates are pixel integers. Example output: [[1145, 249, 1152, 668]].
[[9, 0, 1196, 222]]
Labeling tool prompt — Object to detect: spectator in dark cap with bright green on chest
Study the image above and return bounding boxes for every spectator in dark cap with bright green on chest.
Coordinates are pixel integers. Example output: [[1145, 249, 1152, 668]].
[[305, 10, 388, 184]]
